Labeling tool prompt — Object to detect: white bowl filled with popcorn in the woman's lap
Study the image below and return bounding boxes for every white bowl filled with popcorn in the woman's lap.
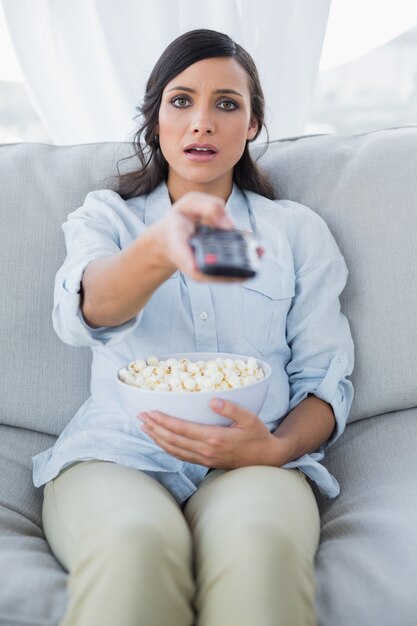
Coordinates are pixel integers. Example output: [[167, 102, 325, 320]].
[[117, 352, 271, 426]]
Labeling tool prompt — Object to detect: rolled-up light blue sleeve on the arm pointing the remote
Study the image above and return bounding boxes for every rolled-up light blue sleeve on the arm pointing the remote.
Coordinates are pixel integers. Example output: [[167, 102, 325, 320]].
[[52, 190, 143, 346]]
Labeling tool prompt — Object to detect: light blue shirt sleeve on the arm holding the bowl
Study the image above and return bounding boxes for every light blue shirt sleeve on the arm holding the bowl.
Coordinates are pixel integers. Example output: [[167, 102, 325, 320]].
[[287, 202, 354, 451]]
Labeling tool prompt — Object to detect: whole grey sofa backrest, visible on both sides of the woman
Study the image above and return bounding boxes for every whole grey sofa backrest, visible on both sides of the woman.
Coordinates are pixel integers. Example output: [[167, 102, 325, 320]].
[[0, 126, 417, 435]]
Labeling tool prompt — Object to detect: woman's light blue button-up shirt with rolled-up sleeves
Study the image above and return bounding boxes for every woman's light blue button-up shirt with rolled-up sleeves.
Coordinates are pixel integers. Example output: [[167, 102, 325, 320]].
[[32, 182, 354, 503]]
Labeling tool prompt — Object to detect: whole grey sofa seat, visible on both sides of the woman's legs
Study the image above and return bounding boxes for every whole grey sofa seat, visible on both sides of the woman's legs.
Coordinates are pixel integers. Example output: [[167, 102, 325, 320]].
[[0, 409, 417, 626]]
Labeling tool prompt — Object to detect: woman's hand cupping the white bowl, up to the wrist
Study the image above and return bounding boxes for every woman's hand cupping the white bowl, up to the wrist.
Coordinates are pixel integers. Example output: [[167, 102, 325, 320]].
[[138, 399, 281, 469]]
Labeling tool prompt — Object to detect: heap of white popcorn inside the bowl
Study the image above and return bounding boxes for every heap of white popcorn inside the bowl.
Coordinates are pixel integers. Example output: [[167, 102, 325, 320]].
[[119, 356, 265, 393]]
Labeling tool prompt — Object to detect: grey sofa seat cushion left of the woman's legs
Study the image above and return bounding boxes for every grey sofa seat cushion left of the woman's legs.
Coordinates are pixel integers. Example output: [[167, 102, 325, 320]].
[[0, 426, 67, 626]]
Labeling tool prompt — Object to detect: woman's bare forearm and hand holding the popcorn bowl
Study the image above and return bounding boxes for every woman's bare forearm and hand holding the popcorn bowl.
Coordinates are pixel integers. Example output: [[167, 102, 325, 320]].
[[137, 396, 336, 469]]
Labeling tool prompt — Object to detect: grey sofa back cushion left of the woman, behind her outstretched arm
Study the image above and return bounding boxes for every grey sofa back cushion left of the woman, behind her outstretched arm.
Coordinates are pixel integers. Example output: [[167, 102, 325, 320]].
[[0, 143, 119, 435]]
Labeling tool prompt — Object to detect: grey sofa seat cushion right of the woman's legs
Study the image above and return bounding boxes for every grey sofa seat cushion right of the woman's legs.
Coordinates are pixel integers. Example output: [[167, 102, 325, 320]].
[[313, 409, 417, 626]]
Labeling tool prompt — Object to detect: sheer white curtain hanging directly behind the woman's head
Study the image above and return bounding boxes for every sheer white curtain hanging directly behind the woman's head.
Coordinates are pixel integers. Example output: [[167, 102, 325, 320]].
[[1, 0, 331, 145]]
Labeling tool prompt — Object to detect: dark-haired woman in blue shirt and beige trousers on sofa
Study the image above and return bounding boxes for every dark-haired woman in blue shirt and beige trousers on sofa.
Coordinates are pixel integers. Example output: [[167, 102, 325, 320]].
[[33, 29, 353, 626]]
